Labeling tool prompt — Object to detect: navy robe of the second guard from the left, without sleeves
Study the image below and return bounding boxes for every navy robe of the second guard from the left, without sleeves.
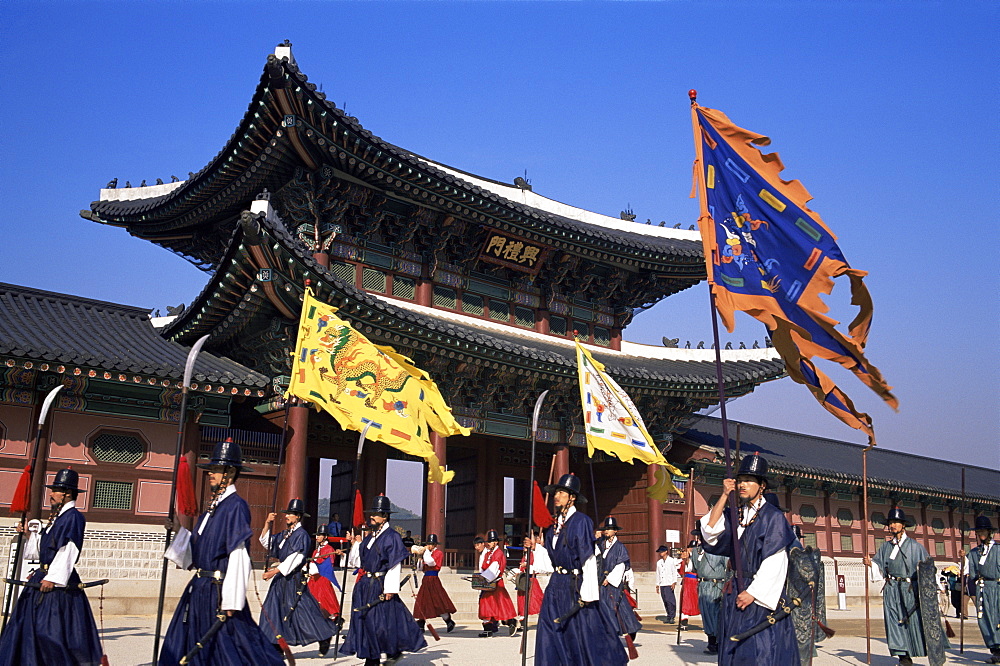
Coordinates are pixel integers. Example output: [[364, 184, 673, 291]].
[[159, 494, 284, 666]]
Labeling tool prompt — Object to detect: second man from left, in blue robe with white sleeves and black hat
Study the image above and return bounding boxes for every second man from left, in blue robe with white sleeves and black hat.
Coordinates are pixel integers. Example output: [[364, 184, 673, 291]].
[[159, 441, 284, 666]]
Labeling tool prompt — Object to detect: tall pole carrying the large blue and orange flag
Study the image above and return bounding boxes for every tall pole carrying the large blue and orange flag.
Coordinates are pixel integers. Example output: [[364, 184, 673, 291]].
[[688, 89, 743, 594]]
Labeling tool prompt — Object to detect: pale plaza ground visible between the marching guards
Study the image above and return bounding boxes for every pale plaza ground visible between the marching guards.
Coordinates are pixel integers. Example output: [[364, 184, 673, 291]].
[[94, 605, 989, 666]]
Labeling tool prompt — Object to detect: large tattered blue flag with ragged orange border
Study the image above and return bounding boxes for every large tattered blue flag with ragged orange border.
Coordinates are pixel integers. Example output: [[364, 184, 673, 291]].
[[691, 102, 898, 443]]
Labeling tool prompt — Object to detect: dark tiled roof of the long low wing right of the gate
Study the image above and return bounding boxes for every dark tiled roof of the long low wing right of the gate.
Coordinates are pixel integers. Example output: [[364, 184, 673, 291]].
[[681, 416, 1000, 503]]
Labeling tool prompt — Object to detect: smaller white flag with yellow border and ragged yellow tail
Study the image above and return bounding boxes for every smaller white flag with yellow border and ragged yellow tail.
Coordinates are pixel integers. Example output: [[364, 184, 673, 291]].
[[576, 342, 686, 502]]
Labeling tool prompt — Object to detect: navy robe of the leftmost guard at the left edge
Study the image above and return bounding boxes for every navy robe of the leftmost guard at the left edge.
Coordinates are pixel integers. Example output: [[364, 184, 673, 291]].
[[0, 507, 101, 666]]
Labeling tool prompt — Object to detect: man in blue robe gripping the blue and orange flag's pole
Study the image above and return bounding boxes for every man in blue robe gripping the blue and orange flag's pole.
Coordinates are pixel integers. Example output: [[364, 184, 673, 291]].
[[701, 454, 800, 666]]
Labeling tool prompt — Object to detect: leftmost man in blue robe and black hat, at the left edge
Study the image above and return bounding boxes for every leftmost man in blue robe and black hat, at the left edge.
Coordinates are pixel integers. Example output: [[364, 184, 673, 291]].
[[0, 469, 102, 666]]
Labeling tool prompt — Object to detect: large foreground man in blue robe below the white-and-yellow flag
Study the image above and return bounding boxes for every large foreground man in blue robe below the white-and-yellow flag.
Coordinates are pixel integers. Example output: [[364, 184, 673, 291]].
[[535, 474, 631, 666]]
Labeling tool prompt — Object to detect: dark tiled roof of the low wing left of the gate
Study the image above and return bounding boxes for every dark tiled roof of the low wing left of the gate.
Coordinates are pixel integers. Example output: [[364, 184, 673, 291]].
[[0, 283, 270, 388]]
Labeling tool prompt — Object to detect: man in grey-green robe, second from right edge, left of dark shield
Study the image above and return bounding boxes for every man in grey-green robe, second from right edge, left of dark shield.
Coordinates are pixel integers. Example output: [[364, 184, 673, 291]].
[[864, 507, 930, 665]]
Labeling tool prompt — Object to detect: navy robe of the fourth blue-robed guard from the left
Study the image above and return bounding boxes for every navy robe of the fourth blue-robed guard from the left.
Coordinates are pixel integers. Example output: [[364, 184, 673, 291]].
[[340, 527, 427, 659]]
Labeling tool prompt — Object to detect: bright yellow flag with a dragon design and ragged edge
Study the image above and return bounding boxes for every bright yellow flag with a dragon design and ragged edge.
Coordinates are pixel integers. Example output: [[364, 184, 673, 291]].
[[285, 289, 471, 483]]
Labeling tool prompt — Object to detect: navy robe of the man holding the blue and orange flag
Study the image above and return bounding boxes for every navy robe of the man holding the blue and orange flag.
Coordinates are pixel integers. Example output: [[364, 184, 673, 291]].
[[704, 503, 800, 666]]
